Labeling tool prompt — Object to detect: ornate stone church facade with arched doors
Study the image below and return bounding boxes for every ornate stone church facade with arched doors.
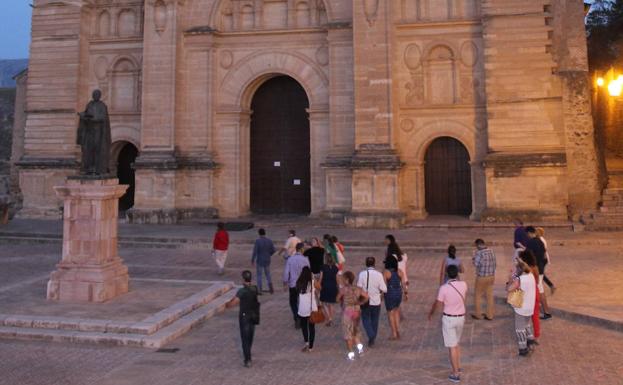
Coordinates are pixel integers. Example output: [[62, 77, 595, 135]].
[[17, 0, 602, 227]]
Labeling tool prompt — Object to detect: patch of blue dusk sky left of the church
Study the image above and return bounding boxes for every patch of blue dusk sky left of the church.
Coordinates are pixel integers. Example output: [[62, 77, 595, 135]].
[[0, 0, 32, 59]]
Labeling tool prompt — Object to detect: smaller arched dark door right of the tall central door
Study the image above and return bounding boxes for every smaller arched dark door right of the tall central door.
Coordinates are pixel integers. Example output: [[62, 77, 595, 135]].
[[424, 137, 472, 215]]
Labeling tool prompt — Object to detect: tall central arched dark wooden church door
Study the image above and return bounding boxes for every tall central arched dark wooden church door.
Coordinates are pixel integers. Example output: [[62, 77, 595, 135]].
[[251, 76, 311, 214]]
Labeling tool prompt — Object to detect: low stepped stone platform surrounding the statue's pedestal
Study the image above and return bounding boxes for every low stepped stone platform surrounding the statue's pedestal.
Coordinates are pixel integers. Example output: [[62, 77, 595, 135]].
[[0, 278, 234, 348]]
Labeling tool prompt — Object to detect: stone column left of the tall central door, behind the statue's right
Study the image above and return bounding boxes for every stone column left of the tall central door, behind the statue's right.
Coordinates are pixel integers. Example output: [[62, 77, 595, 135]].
[[135, 0, 182, 223]]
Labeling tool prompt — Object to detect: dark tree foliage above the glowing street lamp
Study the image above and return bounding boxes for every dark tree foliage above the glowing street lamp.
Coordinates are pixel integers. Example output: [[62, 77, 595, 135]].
[[586, 0, 623, 71]]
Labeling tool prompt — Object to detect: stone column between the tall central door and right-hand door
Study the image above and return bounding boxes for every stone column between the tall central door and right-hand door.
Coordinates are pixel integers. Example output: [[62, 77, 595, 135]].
[[345, 0, 405, 228]]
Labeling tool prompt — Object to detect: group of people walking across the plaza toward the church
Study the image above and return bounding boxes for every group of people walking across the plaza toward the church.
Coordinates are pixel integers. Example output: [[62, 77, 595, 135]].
[[227, 221, 555, 382]]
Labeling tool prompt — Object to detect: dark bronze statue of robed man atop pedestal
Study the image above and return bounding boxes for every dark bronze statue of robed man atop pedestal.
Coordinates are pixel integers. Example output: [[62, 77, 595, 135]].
[[77, 90, 111, 176]]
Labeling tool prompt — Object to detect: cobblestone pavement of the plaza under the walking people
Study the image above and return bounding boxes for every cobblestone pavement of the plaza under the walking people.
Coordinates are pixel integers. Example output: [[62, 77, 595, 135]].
[[0, 240, 623, 385]]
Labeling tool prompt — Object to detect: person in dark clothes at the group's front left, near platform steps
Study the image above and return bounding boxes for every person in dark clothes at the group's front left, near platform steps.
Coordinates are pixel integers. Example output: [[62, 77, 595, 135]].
[[225, 270, 260, 368]]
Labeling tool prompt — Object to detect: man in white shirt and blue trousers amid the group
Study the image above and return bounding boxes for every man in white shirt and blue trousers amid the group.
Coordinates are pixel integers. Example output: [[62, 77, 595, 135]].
[[357, 257, 387, 347]]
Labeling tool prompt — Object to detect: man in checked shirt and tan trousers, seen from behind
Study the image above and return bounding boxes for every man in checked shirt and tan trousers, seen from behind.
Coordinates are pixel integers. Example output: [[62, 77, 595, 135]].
[[472, 239, 496, 321]]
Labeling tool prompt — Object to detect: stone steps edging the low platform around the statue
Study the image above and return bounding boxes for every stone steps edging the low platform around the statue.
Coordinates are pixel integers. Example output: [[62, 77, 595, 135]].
[[0, 283, 235, 349]]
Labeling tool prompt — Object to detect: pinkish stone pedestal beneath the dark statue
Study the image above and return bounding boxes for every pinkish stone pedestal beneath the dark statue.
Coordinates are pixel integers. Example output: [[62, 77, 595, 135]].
[[47, 177, 129, 302]]
